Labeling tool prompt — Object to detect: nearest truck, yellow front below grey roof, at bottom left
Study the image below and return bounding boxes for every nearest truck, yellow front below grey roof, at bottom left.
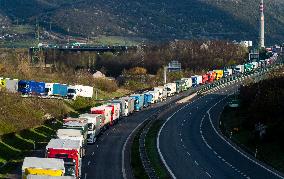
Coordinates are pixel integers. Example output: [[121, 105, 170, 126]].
[[22, 157, 65, 179]]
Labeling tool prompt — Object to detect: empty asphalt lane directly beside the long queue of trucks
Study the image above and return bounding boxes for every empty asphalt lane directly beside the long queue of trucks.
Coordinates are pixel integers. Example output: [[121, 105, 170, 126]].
[[82, 92, 191, 179]]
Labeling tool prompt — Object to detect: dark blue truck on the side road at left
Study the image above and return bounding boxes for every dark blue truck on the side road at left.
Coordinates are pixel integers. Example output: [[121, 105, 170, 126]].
[[18, 80, 45, 96]]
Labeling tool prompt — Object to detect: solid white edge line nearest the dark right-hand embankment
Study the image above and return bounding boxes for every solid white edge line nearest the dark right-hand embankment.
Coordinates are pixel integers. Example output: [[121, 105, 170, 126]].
[[207, 96, 284, 179]]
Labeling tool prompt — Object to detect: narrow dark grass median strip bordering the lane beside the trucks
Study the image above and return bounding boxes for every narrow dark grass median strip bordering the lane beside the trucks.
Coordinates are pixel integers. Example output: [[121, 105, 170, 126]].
[[131, 124, 148, 179]]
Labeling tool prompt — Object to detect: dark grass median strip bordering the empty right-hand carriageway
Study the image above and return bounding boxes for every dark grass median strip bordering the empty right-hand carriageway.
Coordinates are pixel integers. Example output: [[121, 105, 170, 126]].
[[145, 120, 171, 179]]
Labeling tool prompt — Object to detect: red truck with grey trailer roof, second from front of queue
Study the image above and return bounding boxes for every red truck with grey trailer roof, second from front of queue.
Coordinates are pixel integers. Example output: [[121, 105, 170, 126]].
[[45, 139, 82, 178]]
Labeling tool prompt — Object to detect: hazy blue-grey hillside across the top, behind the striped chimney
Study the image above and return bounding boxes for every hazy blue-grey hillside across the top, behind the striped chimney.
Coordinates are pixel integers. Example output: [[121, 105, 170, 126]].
[[0, 0, 284, 42]]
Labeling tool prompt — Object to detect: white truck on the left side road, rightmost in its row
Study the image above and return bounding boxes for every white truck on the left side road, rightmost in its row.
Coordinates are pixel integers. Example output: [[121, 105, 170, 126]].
[[67, 85, 94, 100]]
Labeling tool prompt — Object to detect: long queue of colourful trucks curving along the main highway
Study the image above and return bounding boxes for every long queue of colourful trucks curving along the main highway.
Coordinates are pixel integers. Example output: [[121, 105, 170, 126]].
[[20, 52, 280, 179]]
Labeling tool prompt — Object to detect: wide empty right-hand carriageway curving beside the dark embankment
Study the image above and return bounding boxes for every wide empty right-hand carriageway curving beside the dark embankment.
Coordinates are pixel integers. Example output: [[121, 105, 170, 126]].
[[158, 83, 283, 179]]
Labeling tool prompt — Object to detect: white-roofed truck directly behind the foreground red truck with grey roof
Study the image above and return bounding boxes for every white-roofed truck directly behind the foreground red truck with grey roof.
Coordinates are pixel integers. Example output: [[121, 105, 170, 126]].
[[56, 129, 87, 157]]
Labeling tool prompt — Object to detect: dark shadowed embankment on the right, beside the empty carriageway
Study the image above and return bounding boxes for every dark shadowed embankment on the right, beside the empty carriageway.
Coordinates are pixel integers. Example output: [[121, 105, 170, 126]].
[[220, 69, 284, 172]]
